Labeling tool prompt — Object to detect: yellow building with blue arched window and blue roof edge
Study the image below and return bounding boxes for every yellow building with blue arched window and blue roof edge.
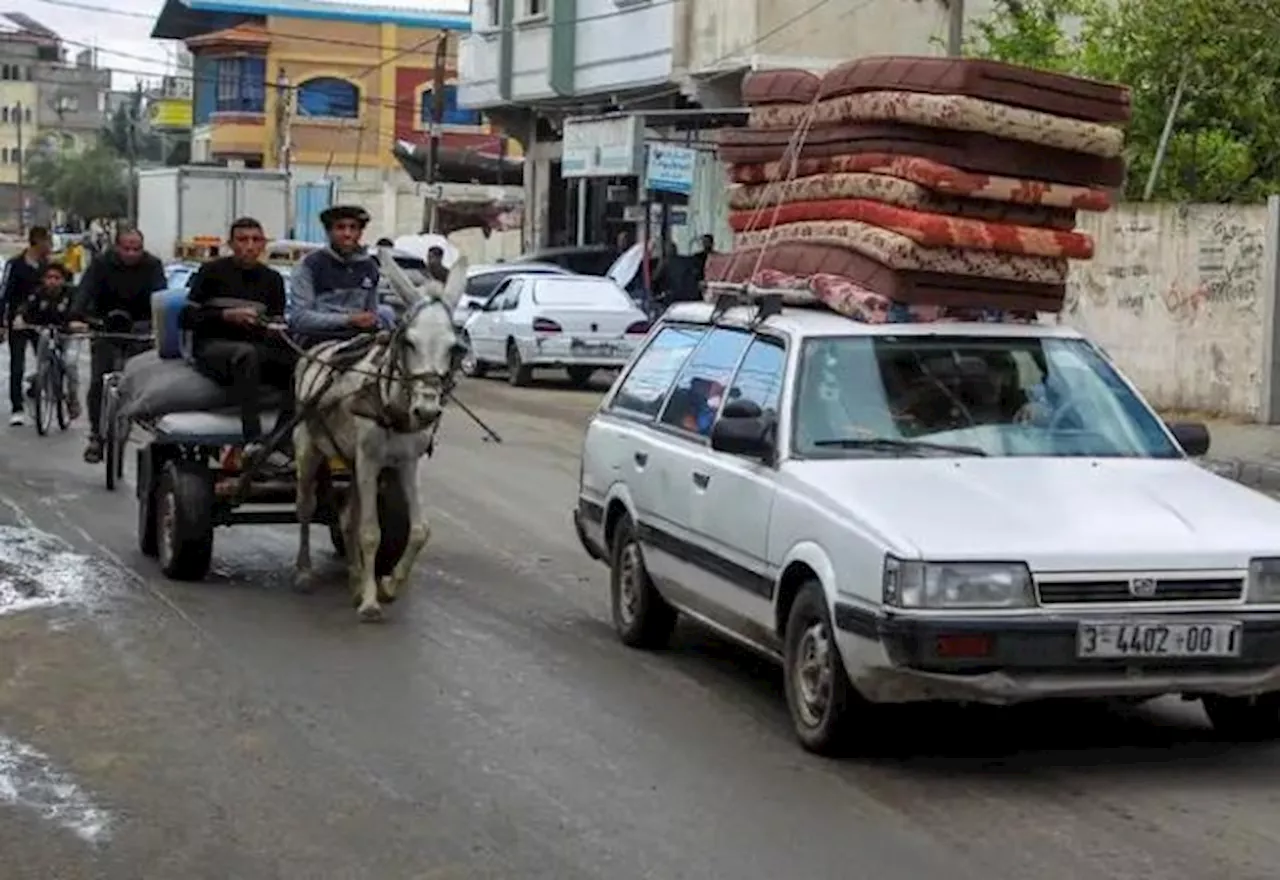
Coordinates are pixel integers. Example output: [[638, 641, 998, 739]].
[[152, 0, 502, 180]]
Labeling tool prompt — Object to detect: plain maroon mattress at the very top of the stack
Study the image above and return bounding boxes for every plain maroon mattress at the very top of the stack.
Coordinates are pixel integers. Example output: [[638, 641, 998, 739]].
[[819, 55, 1133, 123]]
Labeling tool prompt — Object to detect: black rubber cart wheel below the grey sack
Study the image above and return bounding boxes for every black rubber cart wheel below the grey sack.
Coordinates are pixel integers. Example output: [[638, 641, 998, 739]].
[[155, 462, 214, 581]]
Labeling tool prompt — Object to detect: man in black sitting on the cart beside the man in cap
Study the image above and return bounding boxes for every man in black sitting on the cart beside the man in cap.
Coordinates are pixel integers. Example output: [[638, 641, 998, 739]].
[[182, 217, 297, 455]]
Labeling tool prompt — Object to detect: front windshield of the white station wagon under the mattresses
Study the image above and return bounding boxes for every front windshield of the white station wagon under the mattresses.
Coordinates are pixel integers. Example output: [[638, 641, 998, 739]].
[[794, 335, 1181, 458]]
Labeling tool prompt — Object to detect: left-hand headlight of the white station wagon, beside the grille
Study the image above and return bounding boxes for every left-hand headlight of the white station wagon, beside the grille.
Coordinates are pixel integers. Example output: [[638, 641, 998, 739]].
[[884, 556, 1036, 609]]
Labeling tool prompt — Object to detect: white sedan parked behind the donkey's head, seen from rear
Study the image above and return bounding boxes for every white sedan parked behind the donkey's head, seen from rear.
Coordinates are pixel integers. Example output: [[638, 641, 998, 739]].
[[462, 275, 649, 385]]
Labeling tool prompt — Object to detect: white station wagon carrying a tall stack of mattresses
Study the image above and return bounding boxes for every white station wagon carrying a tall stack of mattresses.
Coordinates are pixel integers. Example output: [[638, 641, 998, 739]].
[[573, 301, 1280, 752]]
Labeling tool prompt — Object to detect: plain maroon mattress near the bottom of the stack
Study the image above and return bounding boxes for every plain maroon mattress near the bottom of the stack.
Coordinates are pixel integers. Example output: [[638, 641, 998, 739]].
[[707, 243, 1066, 312]]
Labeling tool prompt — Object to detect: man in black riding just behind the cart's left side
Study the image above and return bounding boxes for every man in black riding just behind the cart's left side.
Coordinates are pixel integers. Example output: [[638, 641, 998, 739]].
[[72, 228, 168, 464]]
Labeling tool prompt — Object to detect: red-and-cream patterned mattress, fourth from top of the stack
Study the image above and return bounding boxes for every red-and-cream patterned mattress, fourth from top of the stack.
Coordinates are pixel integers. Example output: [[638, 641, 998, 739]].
[[730, 153, 1111, 211]]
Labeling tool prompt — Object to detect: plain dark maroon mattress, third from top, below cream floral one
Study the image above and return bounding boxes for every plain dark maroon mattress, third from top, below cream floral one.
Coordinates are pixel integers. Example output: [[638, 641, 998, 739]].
[[719, 123, 1125, 188]]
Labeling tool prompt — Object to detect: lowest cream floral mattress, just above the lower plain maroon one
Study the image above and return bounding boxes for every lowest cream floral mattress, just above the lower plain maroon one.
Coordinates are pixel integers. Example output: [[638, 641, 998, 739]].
[[735, 220, 1068, 289]]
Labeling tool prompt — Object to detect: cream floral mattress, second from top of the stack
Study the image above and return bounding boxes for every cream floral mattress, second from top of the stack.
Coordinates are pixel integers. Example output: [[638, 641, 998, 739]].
[[749, 91, 1124, 159]]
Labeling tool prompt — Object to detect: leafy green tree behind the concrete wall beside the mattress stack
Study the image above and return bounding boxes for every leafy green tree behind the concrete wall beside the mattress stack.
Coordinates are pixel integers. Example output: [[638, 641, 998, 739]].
[[968, 0, 1280, 202]]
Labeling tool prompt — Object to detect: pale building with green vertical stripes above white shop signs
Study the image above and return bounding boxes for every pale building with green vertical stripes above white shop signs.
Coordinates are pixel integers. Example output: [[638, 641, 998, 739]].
[[458, 0, 993, 248]]
